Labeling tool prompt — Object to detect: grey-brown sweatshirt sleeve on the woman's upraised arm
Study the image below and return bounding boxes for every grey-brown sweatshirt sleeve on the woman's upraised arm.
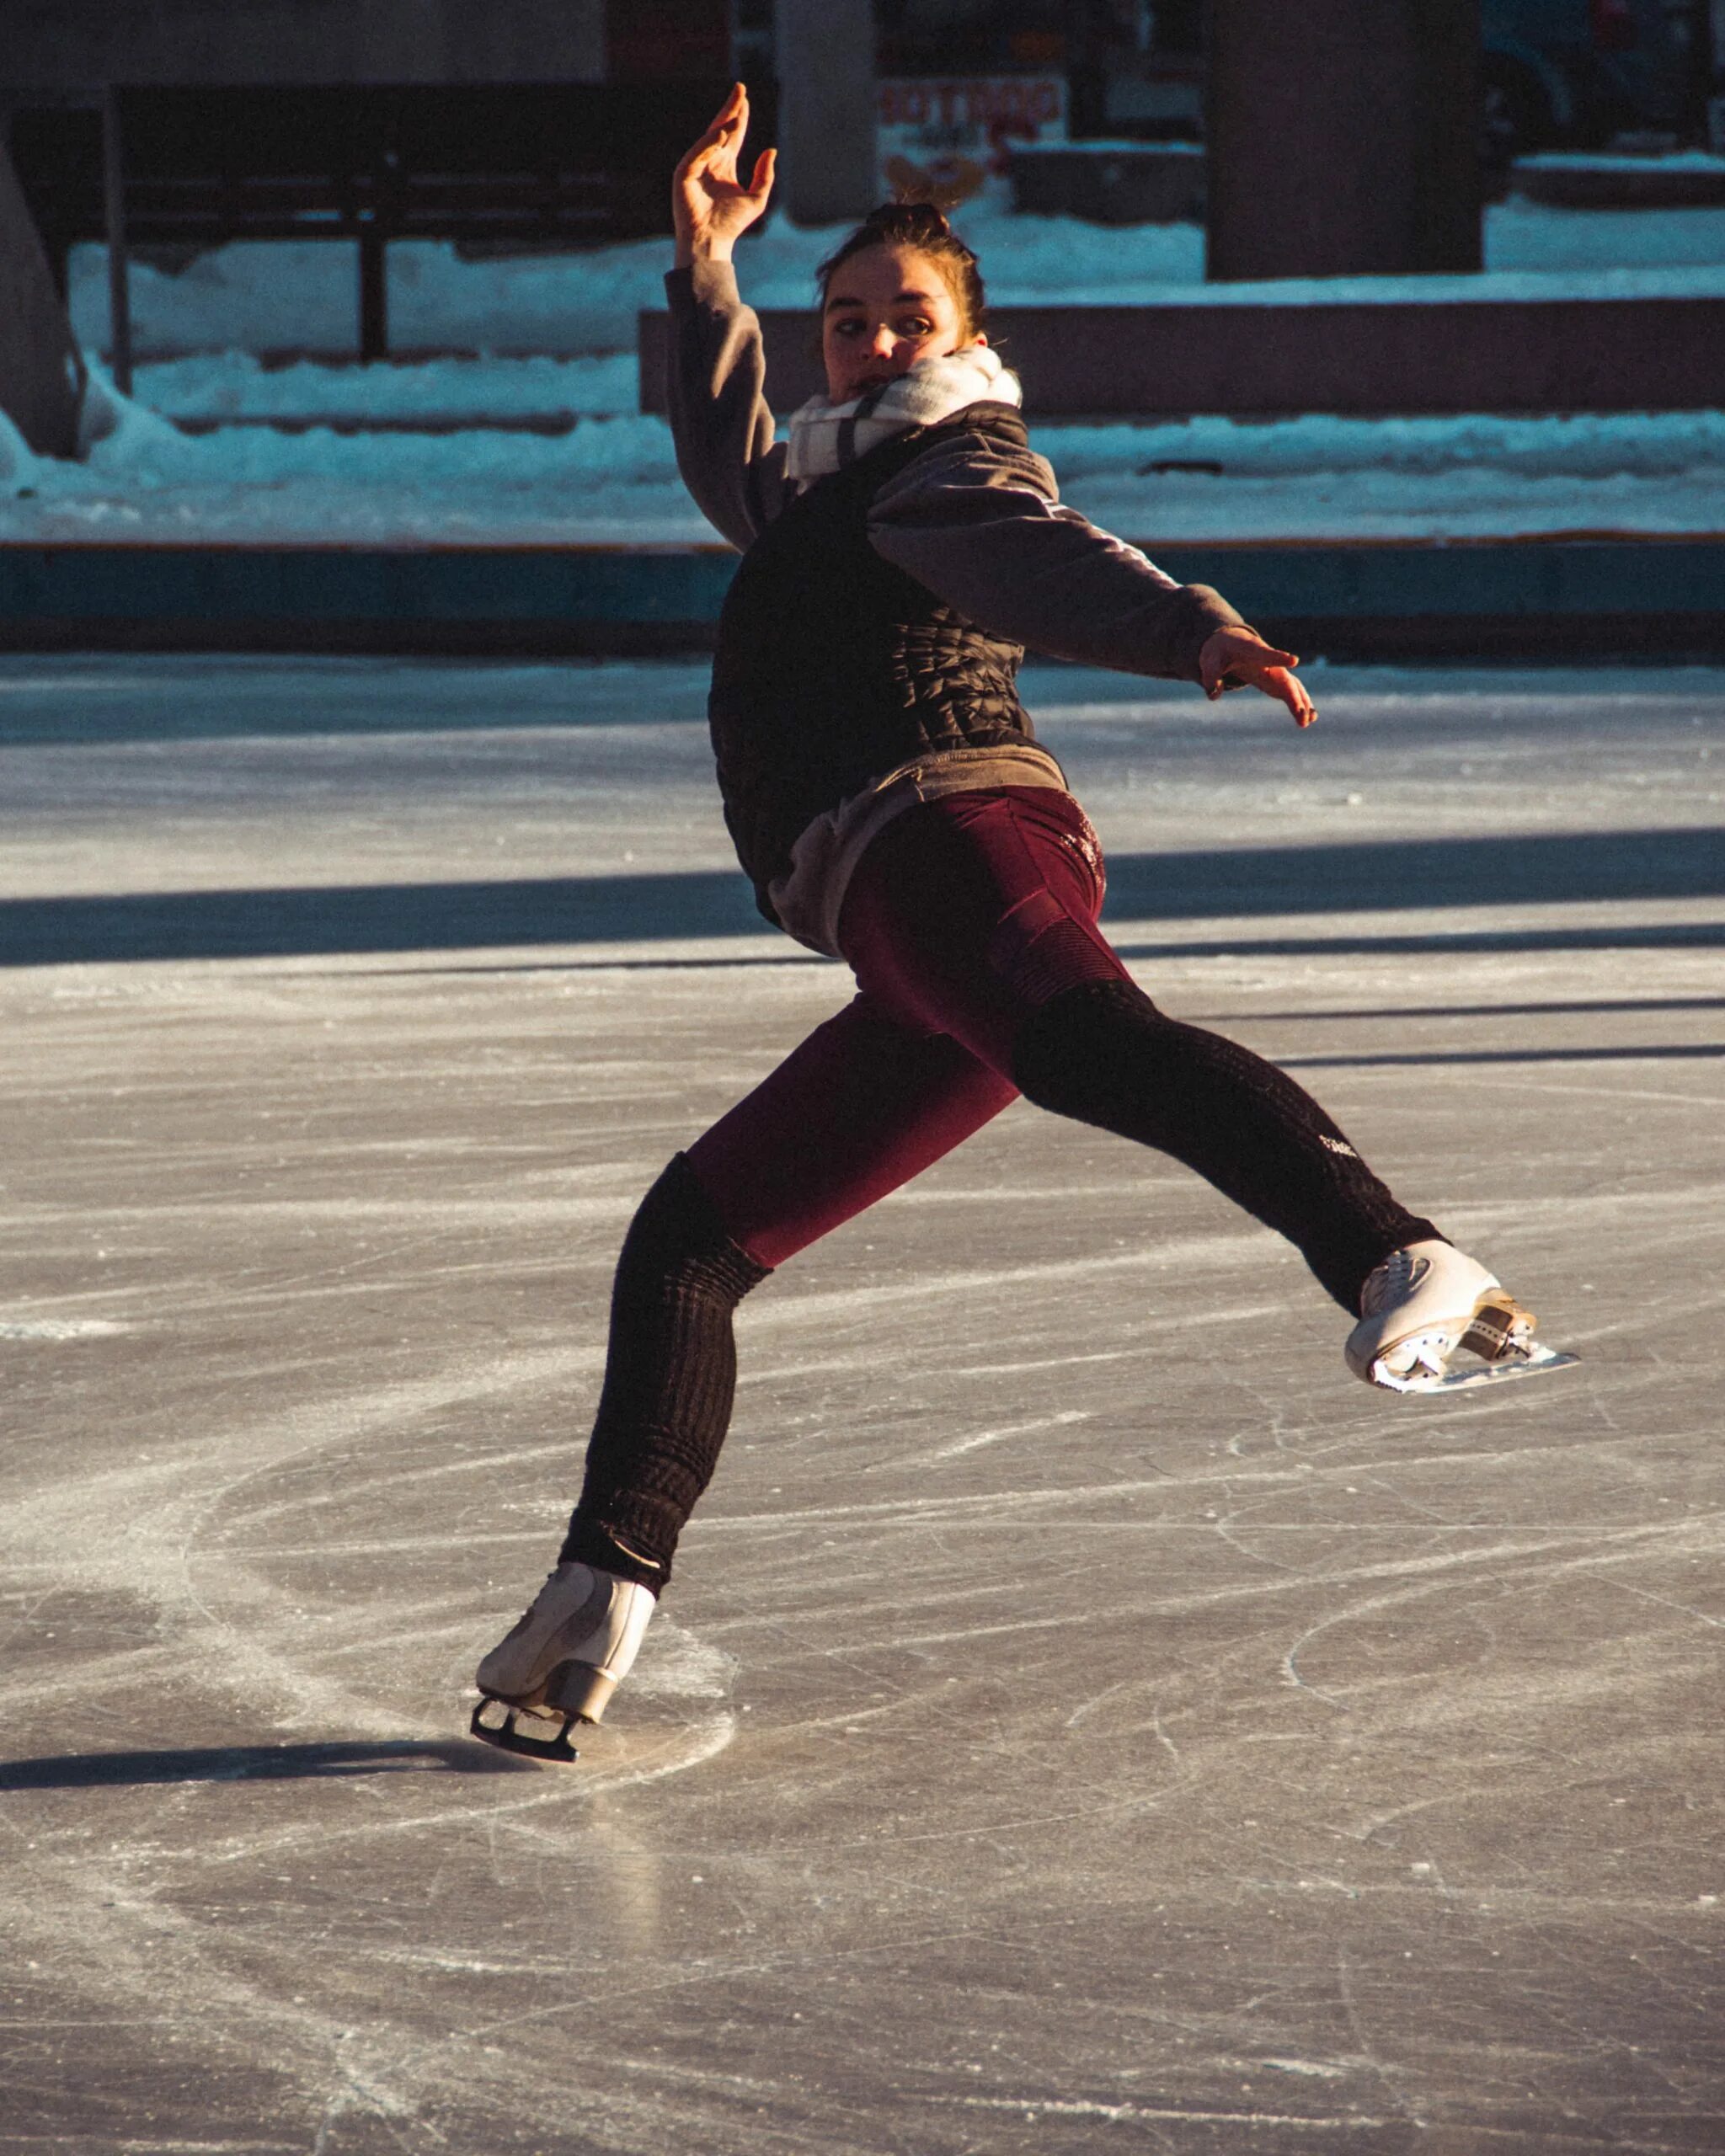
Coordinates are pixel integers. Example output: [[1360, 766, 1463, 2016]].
[[664, 261, 785, 547]]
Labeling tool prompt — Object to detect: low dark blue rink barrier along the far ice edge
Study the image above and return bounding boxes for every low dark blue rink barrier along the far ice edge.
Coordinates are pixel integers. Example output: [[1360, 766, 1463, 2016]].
[[0, 532, 1725, 658]]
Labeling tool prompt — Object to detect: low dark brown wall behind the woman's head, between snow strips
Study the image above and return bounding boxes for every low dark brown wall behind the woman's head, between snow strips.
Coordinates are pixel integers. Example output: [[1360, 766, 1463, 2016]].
[[636, 297, 1725, 420]]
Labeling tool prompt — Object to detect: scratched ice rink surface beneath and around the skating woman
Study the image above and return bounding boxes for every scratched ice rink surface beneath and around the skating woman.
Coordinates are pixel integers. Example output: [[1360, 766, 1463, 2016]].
[[0, 658, 1725, 2156]]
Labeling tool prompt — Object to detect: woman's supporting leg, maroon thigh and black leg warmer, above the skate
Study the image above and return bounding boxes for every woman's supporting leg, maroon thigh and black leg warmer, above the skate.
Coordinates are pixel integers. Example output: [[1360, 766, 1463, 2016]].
[[563, 998, 1016, 1591]]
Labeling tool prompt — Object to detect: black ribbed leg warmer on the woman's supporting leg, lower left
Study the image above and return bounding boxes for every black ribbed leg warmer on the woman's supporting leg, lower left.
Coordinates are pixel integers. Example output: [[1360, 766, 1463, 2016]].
[[563, 1154, 772, 1591]]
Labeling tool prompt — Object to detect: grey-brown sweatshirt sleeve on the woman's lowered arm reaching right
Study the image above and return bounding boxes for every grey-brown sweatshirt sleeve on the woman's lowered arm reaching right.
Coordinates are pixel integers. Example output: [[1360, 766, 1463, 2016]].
[[869, 422, 1240, 681]]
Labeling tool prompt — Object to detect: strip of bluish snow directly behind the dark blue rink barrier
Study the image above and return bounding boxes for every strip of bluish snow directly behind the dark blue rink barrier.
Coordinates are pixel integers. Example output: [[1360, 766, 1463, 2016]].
[[17, 383, 1725, 547]]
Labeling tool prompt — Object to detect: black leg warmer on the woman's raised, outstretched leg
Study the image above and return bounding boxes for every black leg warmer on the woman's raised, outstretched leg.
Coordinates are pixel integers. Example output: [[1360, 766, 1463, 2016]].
[[1013, 981, 1439, 1317]]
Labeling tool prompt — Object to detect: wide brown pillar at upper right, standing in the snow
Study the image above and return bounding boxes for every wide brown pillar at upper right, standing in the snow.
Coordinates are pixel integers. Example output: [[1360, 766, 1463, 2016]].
[[1205, 0, 1482, 280]]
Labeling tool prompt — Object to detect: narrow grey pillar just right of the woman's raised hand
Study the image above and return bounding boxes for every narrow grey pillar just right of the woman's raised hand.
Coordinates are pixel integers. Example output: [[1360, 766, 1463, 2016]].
[[776, 0, 882, 224]]
